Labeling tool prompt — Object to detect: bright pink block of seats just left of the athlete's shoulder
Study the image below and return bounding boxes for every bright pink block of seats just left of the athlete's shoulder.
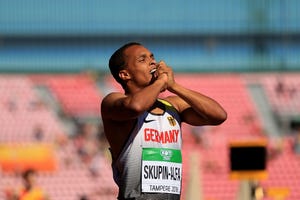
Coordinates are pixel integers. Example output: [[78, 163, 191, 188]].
[[32, 74, 101, 117]]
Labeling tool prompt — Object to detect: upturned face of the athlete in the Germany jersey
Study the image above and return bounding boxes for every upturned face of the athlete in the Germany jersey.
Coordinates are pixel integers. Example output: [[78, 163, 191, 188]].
[[125, 45, 156, 87]]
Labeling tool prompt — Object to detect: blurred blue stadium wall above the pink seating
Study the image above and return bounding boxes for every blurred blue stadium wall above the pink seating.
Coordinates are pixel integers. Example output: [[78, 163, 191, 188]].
[[0, 0, 300, 72]]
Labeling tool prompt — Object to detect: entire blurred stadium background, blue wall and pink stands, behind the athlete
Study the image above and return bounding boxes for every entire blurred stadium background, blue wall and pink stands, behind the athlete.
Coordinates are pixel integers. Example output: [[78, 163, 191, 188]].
[[0, 0, 300, 200]]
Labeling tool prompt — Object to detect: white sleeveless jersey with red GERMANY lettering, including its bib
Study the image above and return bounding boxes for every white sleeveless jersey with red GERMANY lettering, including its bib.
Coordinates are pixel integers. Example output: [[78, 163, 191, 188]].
[[112, 100, 182, 198]]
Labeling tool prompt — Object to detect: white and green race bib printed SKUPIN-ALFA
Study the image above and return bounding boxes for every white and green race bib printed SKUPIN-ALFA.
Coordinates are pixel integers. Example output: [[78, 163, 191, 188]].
[[142, 148, 182, 194]]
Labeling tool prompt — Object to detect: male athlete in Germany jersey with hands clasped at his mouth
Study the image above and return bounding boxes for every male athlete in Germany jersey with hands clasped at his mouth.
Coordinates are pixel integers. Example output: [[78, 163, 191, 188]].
[[101, 42, 227, 200]]
